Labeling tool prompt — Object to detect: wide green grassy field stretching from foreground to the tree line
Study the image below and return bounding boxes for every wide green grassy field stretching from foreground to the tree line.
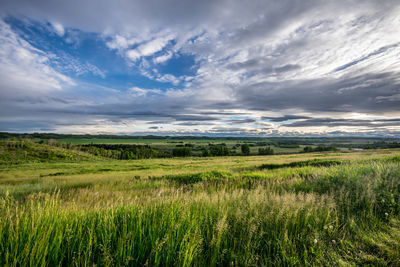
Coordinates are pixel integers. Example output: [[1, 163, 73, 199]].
[[0, 141, 400, 266]]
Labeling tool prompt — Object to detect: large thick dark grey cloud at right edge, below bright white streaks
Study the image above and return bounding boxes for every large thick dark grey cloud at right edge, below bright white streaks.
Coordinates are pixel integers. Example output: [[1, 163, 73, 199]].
[[236, 73, 400, 114]]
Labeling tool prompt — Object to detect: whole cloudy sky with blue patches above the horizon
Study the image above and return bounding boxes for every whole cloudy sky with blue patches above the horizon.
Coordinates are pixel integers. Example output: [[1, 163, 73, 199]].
[[0, 0, 400, 137]]
